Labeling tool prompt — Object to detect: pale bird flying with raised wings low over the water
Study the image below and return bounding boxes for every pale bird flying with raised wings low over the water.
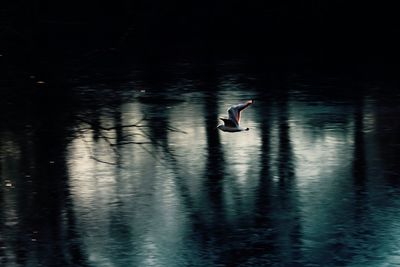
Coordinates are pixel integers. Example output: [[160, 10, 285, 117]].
[[217, 100, 254, 133]]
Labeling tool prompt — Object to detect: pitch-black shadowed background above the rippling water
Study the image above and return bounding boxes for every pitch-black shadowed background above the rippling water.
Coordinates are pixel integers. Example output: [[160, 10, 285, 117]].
[[0, 0, 400, 80]]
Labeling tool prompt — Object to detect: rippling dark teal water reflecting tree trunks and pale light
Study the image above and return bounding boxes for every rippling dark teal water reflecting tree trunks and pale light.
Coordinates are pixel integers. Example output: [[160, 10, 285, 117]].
[[0, 64, 400, 267]]
